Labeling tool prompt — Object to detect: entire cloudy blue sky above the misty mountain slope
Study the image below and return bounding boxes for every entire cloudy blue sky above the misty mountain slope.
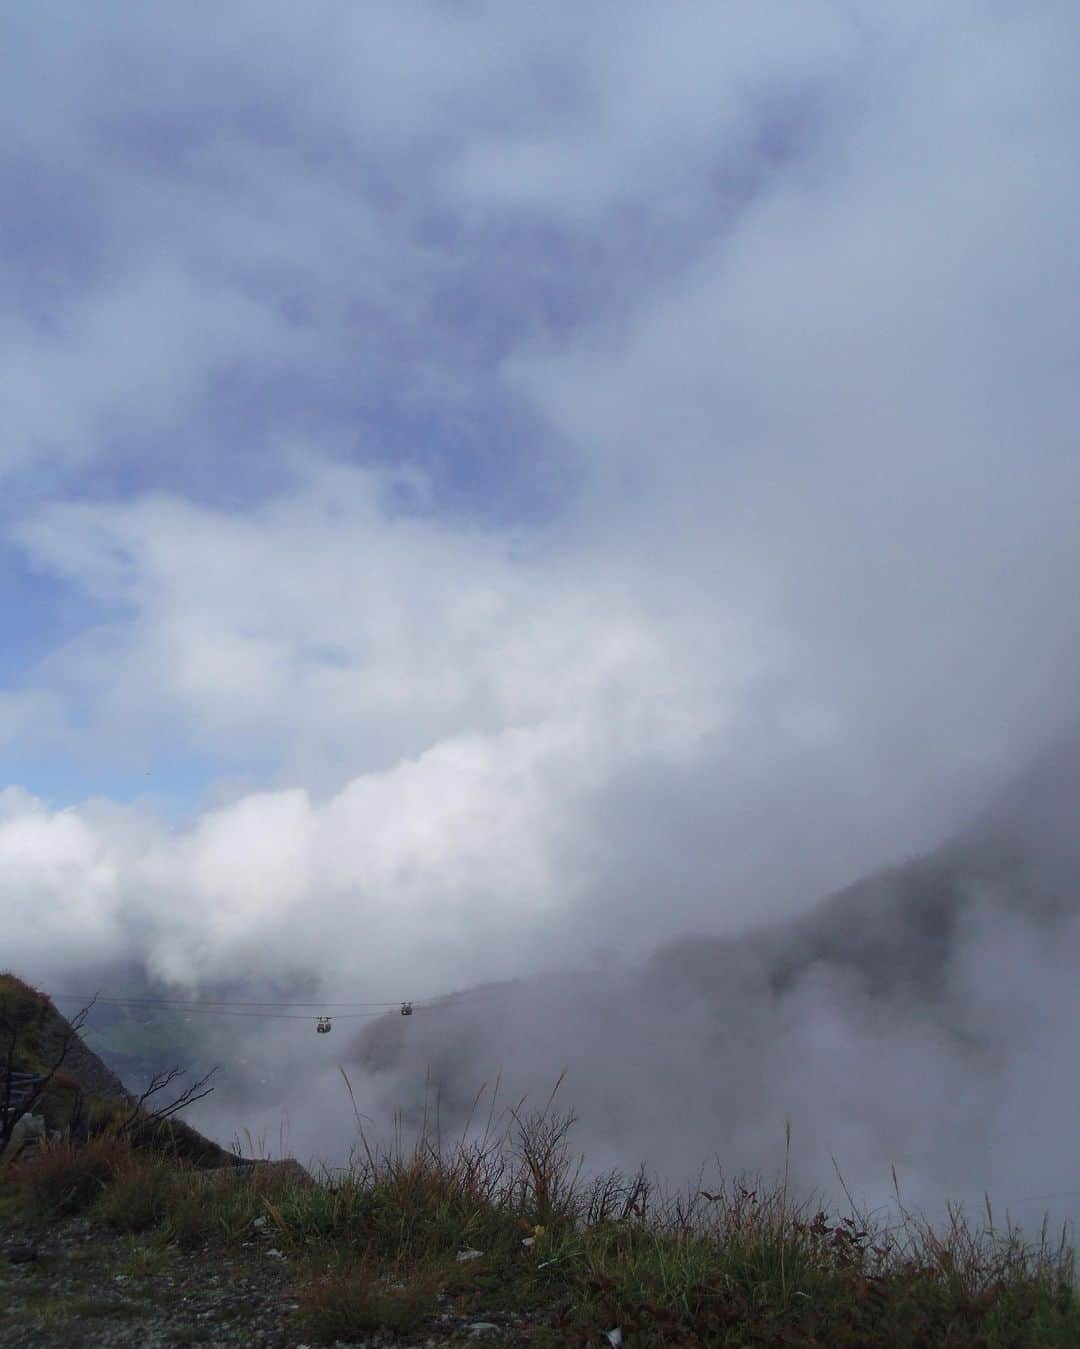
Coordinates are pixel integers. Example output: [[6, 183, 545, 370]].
[[0, 0, 1080, 1214]]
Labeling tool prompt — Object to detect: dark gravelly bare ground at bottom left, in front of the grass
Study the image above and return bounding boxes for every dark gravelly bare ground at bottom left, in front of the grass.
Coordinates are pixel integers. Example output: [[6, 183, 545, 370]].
[[0, 1218, 556, 1349]]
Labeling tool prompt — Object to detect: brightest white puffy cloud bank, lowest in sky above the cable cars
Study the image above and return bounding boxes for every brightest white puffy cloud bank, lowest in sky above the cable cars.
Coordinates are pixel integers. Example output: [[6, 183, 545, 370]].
[[0, 726, 717, 997]]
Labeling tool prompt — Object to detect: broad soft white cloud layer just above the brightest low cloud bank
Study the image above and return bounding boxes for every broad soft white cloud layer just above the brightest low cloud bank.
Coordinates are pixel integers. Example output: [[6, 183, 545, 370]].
[[20, 469, 758, 782]]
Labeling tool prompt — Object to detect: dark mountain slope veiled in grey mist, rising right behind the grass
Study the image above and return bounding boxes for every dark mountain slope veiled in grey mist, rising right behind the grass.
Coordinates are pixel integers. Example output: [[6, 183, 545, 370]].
[[326, 737, 1080, 1221]]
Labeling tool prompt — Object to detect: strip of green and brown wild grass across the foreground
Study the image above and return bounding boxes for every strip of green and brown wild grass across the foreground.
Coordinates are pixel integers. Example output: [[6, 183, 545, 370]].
[[0, 1084, 1080, 1349]]
